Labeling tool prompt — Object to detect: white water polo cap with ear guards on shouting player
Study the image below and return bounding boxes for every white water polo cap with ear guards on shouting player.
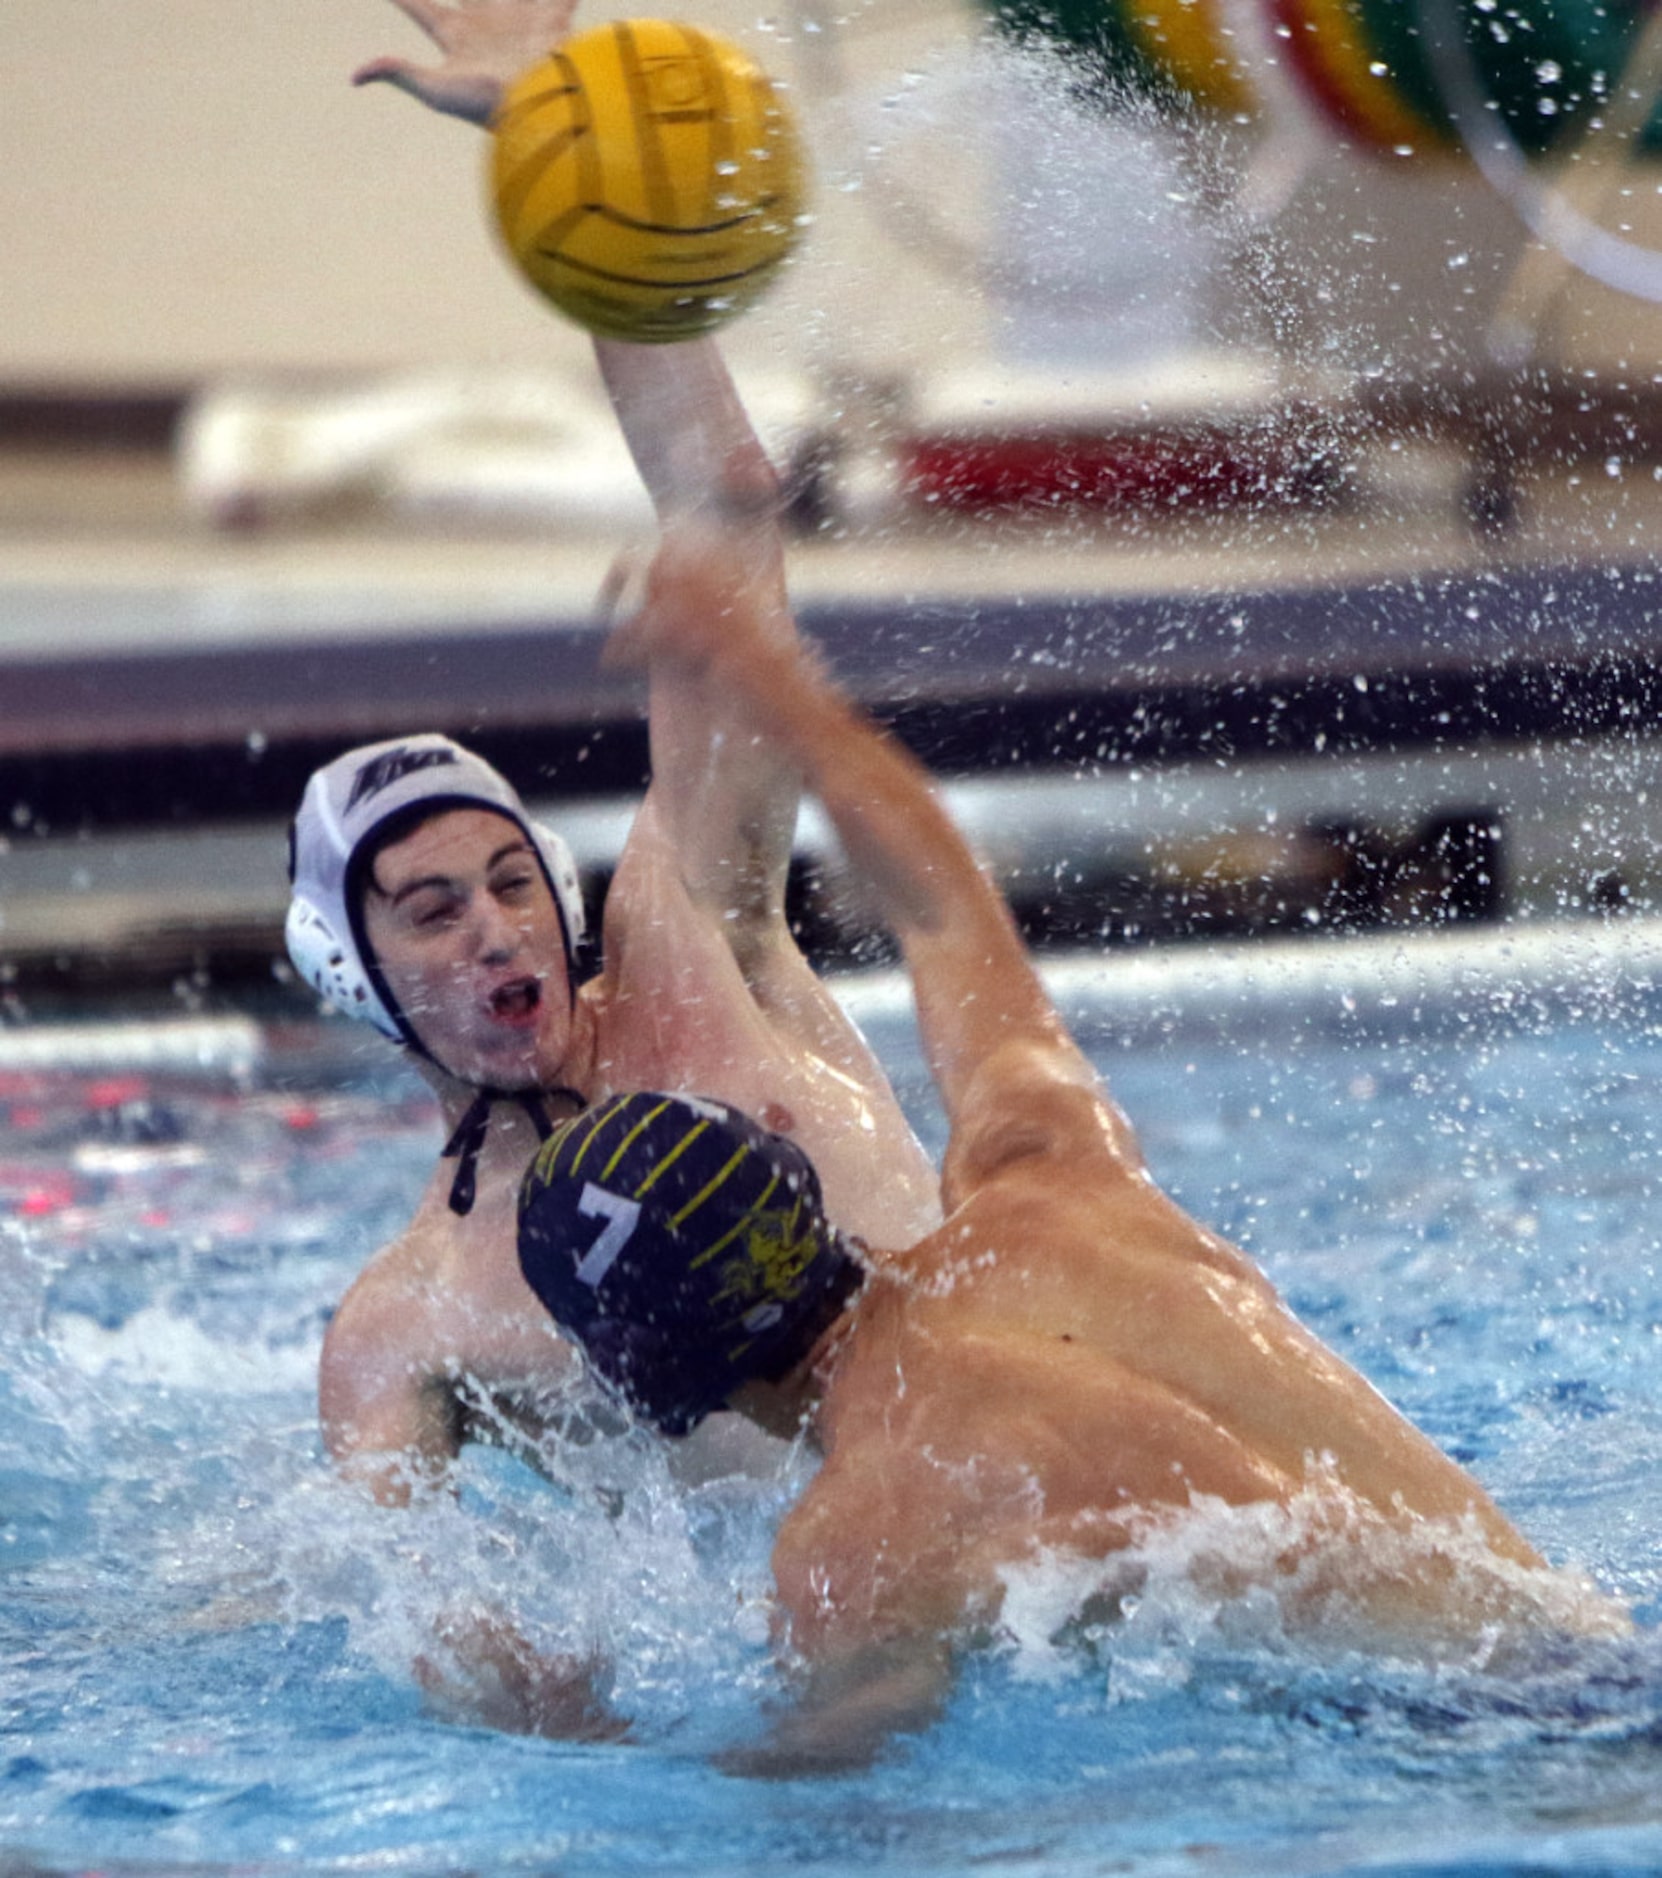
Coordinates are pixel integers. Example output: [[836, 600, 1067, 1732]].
[[284, 734, 584, 1054]]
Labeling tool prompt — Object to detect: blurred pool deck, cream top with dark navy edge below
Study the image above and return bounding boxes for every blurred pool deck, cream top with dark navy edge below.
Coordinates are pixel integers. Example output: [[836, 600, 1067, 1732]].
[[0, 439, 1662, 792]]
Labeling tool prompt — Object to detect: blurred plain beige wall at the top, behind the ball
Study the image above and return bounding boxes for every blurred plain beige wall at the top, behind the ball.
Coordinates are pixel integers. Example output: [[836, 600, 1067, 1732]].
[[12, 0, 1662, 385]]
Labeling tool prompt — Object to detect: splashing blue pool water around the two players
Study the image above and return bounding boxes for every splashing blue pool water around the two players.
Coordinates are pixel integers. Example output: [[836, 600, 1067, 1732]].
[[0, 927, 1662, 1878]]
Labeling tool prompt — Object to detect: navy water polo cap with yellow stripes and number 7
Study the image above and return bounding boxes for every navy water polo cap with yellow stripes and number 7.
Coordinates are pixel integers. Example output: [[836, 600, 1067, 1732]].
[[518, 1095, 864, 1435]]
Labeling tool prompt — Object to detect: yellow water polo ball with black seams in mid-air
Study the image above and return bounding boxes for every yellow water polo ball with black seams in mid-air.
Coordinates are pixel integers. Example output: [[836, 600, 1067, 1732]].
[[490, 19, 806, 344]]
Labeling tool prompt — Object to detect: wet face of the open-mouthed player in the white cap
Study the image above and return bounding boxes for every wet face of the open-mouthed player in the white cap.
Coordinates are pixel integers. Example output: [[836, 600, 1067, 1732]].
[[362, 808, 571, 1089]]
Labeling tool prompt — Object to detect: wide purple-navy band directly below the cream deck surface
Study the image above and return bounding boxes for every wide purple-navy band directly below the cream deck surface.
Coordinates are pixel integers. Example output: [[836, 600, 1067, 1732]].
[[0, 567, 1662, 832]]
